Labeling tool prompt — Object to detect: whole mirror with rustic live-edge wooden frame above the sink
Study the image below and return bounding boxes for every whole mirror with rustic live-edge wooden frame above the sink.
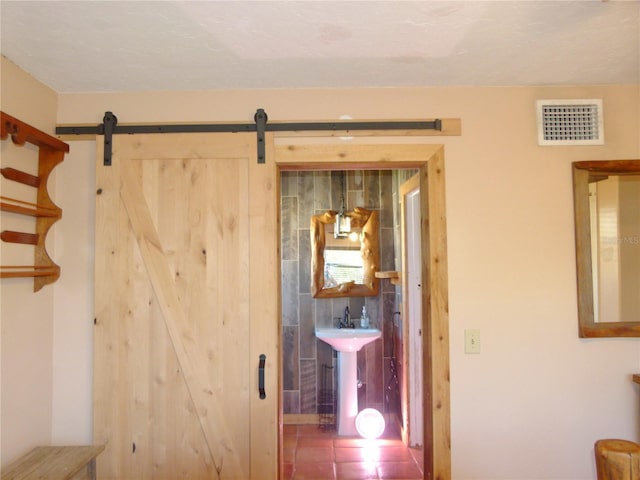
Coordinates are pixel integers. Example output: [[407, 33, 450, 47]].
[[310, 207, 380, 298]]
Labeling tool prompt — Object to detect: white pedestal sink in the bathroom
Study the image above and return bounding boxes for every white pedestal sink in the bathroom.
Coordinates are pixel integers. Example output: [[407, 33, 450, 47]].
[[316, 328, 382, 435]]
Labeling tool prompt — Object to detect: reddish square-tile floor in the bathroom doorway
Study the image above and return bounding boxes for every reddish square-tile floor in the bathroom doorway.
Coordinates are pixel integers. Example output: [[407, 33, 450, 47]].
[[283, 425, 423, 480]]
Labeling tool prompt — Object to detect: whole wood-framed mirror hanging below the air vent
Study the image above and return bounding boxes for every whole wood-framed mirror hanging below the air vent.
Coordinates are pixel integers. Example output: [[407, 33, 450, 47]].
[[573, 160, 640, 337]]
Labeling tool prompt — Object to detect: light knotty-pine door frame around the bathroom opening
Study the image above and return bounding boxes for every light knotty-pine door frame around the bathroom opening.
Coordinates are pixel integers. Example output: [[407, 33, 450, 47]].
[[274, 139, 451, 480]]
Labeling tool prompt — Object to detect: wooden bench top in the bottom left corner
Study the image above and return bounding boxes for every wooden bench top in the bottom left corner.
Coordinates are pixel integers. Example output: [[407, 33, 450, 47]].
[[0, 445, 104, 480]]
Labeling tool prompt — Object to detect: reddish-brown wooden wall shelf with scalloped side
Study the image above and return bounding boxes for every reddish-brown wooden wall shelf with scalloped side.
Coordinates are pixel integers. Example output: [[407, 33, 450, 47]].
[[0, 112, 69, 292]]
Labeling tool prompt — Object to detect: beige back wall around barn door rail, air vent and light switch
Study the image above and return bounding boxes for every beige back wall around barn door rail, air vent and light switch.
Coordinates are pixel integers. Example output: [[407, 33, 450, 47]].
[[2, 52, 640, 479]]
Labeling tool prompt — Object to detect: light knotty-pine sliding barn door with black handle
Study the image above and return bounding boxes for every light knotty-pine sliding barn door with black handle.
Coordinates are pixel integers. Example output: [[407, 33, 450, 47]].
[[94, 134, 278, 480]]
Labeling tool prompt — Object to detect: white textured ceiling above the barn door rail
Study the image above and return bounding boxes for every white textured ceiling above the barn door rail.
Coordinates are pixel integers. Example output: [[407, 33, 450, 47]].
[[0, 0, 640, 92]]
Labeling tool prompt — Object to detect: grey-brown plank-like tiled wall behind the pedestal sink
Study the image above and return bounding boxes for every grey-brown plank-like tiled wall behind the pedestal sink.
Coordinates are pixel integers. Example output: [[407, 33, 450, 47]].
[[281, 170, 416, 414]]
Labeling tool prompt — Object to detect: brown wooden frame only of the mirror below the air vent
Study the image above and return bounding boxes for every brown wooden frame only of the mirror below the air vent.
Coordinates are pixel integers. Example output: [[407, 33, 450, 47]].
[[572, 160, 640, 338]]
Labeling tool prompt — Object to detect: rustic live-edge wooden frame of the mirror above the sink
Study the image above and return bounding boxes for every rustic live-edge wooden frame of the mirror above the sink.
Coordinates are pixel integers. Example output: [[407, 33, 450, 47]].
[[310, 207, 380, 298]]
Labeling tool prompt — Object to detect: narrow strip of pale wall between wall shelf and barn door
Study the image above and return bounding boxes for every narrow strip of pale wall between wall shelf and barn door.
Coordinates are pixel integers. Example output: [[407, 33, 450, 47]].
[[51, 131, 95, 444]]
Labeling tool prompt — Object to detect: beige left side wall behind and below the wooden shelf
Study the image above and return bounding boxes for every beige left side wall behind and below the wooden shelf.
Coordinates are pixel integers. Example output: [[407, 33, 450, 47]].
[[0, 57, 58, 465]]
